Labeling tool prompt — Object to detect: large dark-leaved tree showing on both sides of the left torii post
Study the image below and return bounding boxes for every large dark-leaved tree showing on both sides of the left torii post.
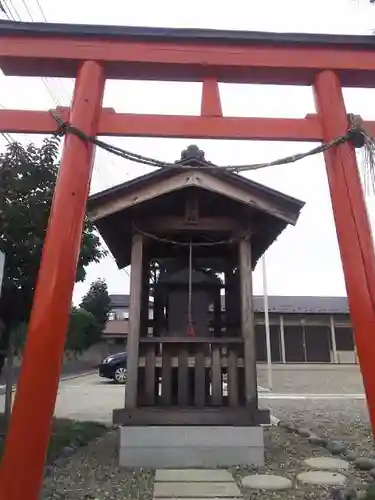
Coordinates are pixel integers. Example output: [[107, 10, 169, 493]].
[[0, 139, 105, 372]]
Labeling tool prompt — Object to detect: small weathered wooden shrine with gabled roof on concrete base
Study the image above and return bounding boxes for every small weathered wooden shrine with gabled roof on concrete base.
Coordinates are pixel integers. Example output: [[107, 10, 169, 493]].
[[89, 146, 303, 467]]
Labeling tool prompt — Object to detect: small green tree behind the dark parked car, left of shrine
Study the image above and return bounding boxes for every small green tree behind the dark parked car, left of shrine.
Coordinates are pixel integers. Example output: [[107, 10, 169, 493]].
[[80, 279, 111, 340]]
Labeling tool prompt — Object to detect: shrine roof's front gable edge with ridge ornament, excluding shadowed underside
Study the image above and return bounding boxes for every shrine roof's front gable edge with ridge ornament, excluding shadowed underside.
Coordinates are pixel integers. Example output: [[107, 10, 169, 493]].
[[88, 146, 304, 224]]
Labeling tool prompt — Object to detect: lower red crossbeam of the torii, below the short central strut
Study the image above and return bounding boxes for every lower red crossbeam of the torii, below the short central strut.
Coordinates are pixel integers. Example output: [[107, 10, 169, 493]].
[[0, 107, 375, 142]]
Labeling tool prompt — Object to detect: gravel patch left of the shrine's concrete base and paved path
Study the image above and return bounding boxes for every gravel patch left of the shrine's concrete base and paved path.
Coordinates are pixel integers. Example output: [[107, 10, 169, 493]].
[[41, 431, 153, 500]]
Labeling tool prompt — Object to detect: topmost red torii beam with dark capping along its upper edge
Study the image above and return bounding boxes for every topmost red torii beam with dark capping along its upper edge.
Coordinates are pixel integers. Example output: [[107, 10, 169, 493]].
[[0, 21, 375, 88]]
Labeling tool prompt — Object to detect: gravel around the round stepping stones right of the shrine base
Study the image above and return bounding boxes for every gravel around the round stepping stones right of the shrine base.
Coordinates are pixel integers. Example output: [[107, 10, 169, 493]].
[[233, 427, 366, 500]]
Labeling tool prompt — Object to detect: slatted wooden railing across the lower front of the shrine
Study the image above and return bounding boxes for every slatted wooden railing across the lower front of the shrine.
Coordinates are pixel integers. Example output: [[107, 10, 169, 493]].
[[138, 337, 245, 408]]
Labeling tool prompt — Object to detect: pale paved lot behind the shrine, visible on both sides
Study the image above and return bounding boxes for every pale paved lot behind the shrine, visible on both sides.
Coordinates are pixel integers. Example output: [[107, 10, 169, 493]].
[[0, 365, 364, 424]]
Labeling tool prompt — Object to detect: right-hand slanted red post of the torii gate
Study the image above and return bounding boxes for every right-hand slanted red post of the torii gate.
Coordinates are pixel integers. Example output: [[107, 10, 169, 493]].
[[314, 70, 375, 437]]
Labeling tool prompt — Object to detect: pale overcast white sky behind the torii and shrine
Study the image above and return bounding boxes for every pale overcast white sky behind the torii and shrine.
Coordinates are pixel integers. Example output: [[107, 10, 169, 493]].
[[0, 0, 375, 302]]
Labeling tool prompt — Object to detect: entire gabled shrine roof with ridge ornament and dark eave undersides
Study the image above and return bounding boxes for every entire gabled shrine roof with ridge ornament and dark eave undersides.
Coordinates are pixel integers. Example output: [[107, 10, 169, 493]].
[[88, 146, 304, 268]]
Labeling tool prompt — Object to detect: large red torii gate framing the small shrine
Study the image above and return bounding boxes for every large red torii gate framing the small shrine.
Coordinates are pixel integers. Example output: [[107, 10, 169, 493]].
[[0, 21, 375, 500]]
